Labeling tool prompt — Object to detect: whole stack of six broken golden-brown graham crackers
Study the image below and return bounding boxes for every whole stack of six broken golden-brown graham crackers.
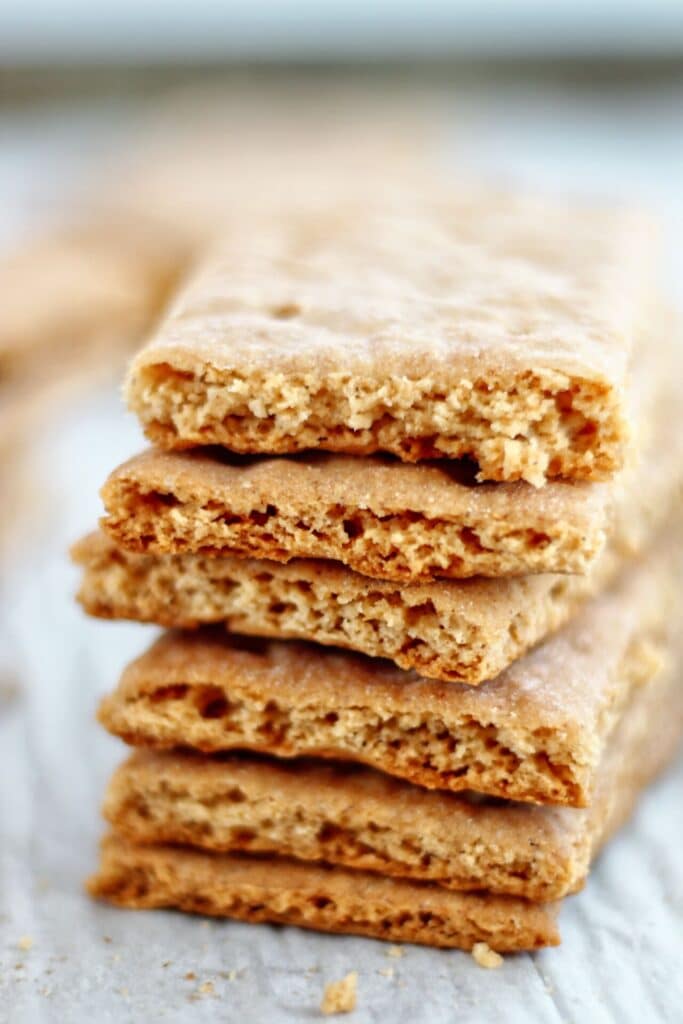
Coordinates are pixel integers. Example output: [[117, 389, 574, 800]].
[[75, 190, 683, 954]]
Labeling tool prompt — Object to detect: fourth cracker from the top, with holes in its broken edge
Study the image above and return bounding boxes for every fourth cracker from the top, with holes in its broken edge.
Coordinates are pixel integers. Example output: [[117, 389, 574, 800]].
[[99, 538, 681, 806]]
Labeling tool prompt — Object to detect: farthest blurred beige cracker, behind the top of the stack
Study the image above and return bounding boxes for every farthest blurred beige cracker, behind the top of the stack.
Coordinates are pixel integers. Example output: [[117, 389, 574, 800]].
[[90, 82, 447, 247]]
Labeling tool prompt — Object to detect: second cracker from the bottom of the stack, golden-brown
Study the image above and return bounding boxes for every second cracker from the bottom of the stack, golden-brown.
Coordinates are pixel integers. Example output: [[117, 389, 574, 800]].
[[103, 647, 683, 902]]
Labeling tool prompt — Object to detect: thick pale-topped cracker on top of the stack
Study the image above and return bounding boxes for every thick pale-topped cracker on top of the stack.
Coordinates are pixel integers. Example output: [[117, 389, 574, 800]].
[[127, 189, 656, 484]]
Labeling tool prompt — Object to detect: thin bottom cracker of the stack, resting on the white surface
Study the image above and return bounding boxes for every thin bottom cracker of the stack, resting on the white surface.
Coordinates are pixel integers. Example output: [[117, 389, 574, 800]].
[[88, 836, 559, 952]]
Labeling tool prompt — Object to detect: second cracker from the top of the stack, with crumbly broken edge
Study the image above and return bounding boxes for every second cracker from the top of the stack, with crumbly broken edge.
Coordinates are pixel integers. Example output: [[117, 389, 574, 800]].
[[102, 450, 613, 583]]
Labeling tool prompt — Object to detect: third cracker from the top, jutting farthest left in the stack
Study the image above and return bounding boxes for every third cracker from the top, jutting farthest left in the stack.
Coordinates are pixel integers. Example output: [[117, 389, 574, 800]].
[[73, 534, 618, 686]]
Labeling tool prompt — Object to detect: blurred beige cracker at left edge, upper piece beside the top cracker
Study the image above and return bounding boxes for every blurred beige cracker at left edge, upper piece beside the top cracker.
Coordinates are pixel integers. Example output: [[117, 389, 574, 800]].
[[0, 221, 187, 390]]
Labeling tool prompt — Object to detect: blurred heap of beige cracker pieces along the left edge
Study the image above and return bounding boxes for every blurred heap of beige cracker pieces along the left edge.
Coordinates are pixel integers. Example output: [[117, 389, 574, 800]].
[[0, 220, 189, 551]]
